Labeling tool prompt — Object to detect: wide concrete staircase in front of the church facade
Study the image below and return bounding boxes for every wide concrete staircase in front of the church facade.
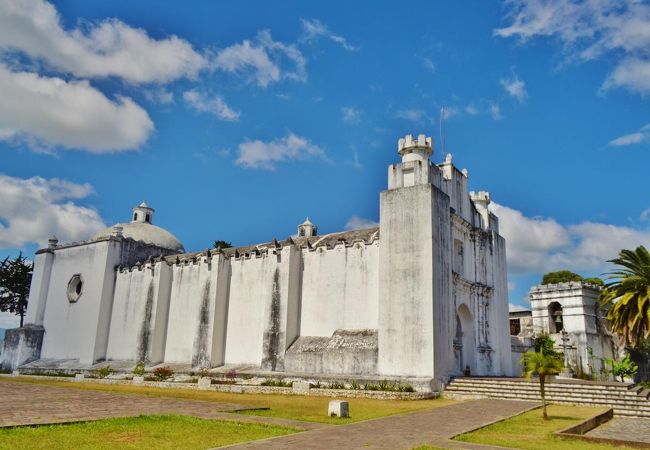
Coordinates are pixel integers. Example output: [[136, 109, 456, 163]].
[[443, 377, 650, 417]]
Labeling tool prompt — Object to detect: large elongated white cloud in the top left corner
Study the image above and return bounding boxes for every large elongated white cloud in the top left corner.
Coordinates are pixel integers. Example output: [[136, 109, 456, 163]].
[[0, 0, 206, 83]]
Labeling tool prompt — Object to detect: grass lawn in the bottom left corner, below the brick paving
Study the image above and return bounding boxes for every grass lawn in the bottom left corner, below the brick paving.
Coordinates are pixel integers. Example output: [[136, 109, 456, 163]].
[[0, 415, 296, 450]]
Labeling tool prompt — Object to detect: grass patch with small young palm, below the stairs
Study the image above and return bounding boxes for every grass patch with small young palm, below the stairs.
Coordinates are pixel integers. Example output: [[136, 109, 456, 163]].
[[456, 405, 623, 450]]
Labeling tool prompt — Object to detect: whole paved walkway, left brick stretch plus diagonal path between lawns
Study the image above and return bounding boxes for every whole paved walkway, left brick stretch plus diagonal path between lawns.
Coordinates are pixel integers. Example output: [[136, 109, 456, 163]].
[[0, 380, 538, 450]]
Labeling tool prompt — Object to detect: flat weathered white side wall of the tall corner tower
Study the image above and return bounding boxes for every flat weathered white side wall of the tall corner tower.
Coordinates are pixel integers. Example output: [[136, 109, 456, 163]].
[[378, 184, 436, 377]]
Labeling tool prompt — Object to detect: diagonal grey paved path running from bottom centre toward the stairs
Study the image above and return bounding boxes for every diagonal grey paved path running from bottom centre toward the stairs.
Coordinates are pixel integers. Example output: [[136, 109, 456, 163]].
[[220, 399, 539, 450]]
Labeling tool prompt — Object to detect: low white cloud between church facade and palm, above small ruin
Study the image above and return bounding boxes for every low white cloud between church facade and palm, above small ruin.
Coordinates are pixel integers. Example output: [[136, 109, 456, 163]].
[[490, 203, 650, 274]]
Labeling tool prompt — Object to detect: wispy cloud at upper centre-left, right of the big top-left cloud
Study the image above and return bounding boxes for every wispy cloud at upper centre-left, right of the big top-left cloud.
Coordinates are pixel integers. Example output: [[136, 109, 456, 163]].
[[214, 30, 307, 87]]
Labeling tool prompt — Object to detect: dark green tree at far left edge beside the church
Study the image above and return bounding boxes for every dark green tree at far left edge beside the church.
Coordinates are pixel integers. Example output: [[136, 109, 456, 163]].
[[0, 253, 34, 327]]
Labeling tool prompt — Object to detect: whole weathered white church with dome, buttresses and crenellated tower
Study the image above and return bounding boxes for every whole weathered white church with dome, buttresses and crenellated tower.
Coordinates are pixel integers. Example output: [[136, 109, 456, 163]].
[[1, 135, 512, 389]]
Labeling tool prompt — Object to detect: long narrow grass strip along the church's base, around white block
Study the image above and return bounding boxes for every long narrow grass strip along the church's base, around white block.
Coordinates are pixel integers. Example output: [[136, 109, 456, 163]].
[[0, 377, 456, 424]]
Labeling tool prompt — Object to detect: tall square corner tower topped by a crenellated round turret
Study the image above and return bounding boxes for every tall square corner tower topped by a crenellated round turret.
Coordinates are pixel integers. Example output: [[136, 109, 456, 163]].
[[378, 134, 455, 379]]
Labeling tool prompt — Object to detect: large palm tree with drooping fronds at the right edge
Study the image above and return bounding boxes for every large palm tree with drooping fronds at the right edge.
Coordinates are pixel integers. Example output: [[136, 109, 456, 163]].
[[600, 245, 650, 347]]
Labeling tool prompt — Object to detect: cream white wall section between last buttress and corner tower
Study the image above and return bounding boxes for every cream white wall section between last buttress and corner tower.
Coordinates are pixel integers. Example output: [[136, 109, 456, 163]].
[[300, 240, 379, 337]]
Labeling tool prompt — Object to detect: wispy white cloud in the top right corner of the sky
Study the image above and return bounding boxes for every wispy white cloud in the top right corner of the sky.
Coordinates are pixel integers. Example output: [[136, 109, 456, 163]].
[[494, 0, 650, 94]]
